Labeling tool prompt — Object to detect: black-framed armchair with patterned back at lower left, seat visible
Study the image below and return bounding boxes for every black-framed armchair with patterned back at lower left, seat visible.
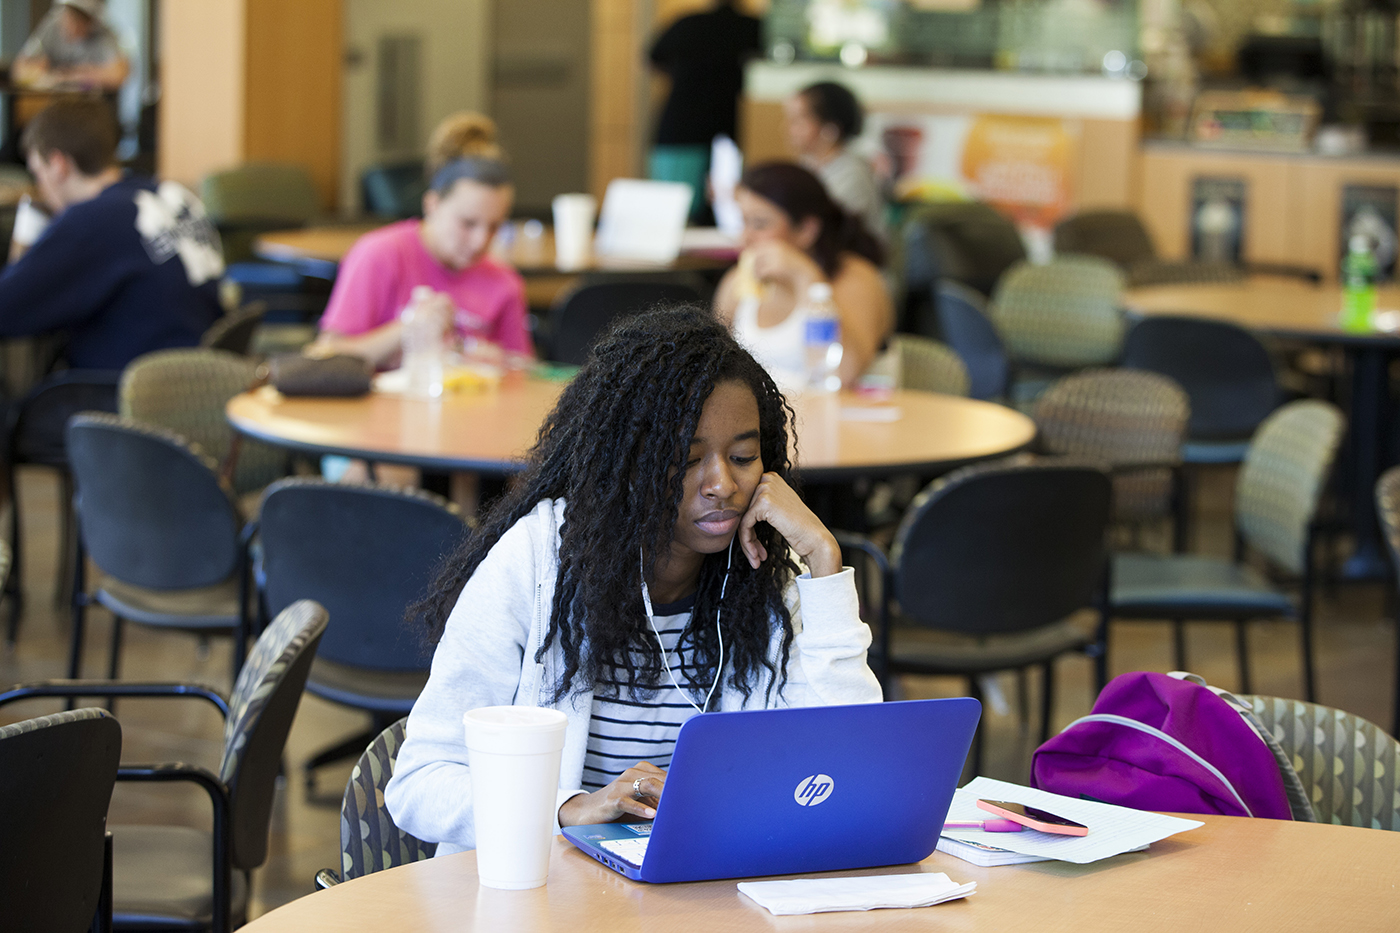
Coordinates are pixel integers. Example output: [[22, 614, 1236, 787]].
[[0, 600, 328, 933]]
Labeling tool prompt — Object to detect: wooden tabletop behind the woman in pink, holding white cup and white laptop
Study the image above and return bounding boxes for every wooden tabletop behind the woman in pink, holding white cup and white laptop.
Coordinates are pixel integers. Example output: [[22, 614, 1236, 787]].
[[253, 223, 734, 276]]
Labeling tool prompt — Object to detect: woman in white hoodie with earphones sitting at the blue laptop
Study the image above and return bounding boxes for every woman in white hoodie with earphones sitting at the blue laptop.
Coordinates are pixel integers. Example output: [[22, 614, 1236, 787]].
[[384, 308, 881, 856]]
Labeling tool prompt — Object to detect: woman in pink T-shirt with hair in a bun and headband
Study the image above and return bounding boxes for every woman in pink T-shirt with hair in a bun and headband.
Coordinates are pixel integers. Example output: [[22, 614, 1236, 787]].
[[312, 113, 533, 368]]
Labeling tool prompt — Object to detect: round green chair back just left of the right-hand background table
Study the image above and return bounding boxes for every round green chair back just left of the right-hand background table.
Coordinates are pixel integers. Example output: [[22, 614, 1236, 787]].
[[991, 256, 1124, 371]]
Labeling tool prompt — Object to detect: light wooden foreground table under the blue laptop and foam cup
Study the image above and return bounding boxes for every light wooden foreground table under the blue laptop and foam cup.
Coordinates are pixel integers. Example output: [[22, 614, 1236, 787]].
[[244, 817, 1400, 933]]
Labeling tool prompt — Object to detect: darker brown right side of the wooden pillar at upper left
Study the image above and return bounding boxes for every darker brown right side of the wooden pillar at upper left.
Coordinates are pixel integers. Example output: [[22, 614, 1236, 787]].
[[244, 0, 344, 210]]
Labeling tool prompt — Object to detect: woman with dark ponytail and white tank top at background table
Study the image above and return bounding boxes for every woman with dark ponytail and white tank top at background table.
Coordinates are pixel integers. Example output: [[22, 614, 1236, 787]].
[[714, 163, 895, 385]]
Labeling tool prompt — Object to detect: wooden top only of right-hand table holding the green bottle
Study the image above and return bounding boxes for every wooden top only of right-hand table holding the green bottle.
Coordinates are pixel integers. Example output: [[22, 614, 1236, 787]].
[[1124, 276, 1400, 345]]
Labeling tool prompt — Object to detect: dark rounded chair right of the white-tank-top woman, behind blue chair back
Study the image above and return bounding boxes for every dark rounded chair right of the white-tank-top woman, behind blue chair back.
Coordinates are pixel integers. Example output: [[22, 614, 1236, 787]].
[[895, 202, 1026, 339]]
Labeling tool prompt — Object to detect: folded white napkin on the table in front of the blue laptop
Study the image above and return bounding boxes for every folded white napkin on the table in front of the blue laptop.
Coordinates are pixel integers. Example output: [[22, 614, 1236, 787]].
[[739, 871, 977, 916]]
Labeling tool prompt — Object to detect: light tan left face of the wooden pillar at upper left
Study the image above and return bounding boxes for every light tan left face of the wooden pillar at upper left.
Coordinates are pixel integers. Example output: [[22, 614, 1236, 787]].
[[157, 0, 246, 188]]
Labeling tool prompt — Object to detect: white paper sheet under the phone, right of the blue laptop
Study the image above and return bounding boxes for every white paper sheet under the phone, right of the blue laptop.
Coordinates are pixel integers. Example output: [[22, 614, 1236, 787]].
[[942, 778, 1204, 864]]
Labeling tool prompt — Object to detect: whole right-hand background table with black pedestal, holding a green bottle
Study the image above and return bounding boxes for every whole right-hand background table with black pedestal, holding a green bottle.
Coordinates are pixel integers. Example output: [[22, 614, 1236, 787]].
[[1124, 276, 1400, 580]]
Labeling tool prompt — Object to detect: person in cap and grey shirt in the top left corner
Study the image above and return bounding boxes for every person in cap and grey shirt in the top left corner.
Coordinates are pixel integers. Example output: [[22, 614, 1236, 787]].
[[10, 0, 130, 91]]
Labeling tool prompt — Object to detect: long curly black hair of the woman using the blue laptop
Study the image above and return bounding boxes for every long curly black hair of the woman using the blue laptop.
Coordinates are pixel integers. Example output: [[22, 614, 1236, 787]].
[[409, 307, 798, 702]]
